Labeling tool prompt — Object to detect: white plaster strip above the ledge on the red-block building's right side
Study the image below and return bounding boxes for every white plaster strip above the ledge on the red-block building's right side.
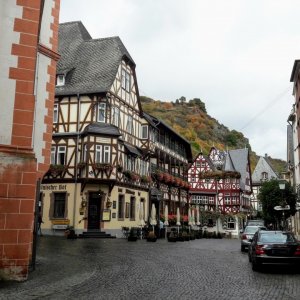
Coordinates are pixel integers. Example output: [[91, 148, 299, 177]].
[[40, 0, 55, 49]]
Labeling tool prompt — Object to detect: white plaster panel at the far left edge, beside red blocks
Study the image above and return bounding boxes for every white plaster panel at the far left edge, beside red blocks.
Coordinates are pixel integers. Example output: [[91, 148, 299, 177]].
[[0, 0, 22, 145]]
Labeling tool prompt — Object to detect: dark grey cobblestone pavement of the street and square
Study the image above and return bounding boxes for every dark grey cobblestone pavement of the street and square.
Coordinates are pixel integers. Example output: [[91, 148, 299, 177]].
[[0, 237, 300, 300]]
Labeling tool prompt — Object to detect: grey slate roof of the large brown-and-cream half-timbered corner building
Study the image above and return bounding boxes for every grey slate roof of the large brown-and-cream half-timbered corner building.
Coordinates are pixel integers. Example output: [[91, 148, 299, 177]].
[[55, 21, 135, 96]]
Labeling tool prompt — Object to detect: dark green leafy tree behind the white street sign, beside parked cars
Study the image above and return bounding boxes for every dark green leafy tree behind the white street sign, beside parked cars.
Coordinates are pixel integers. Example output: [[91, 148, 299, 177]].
[[258, 179, 296, 224]]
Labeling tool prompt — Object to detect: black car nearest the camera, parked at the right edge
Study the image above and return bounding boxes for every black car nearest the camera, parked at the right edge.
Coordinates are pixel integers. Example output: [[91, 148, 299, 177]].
[[248, 231, 300, 271]]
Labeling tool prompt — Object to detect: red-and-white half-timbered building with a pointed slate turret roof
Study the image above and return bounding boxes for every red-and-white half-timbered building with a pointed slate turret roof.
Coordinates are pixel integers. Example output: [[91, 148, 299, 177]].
[[188, 147, 252, 235]]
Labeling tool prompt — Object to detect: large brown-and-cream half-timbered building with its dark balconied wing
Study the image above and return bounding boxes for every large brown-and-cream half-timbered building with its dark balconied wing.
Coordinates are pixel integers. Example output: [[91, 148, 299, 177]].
[[41, 22, 191, 236]]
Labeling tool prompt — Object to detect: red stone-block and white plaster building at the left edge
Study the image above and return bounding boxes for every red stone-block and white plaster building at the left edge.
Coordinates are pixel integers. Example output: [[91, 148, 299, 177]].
[[0, 0, 60, 280]]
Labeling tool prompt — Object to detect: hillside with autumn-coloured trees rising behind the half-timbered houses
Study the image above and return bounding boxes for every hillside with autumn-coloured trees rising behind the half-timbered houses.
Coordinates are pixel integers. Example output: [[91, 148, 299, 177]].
[[141, 96, 286, 172]]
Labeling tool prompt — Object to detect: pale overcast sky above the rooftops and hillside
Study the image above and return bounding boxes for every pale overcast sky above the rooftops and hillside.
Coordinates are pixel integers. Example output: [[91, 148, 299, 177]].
[[60, 0, 300, 160]]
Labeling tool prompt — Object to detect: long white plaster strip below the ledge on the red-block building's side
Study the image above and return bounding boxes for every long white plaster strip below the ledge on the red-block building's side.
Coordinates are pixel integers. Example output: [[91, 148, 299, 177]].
[[32, 53, 51, 163]]
